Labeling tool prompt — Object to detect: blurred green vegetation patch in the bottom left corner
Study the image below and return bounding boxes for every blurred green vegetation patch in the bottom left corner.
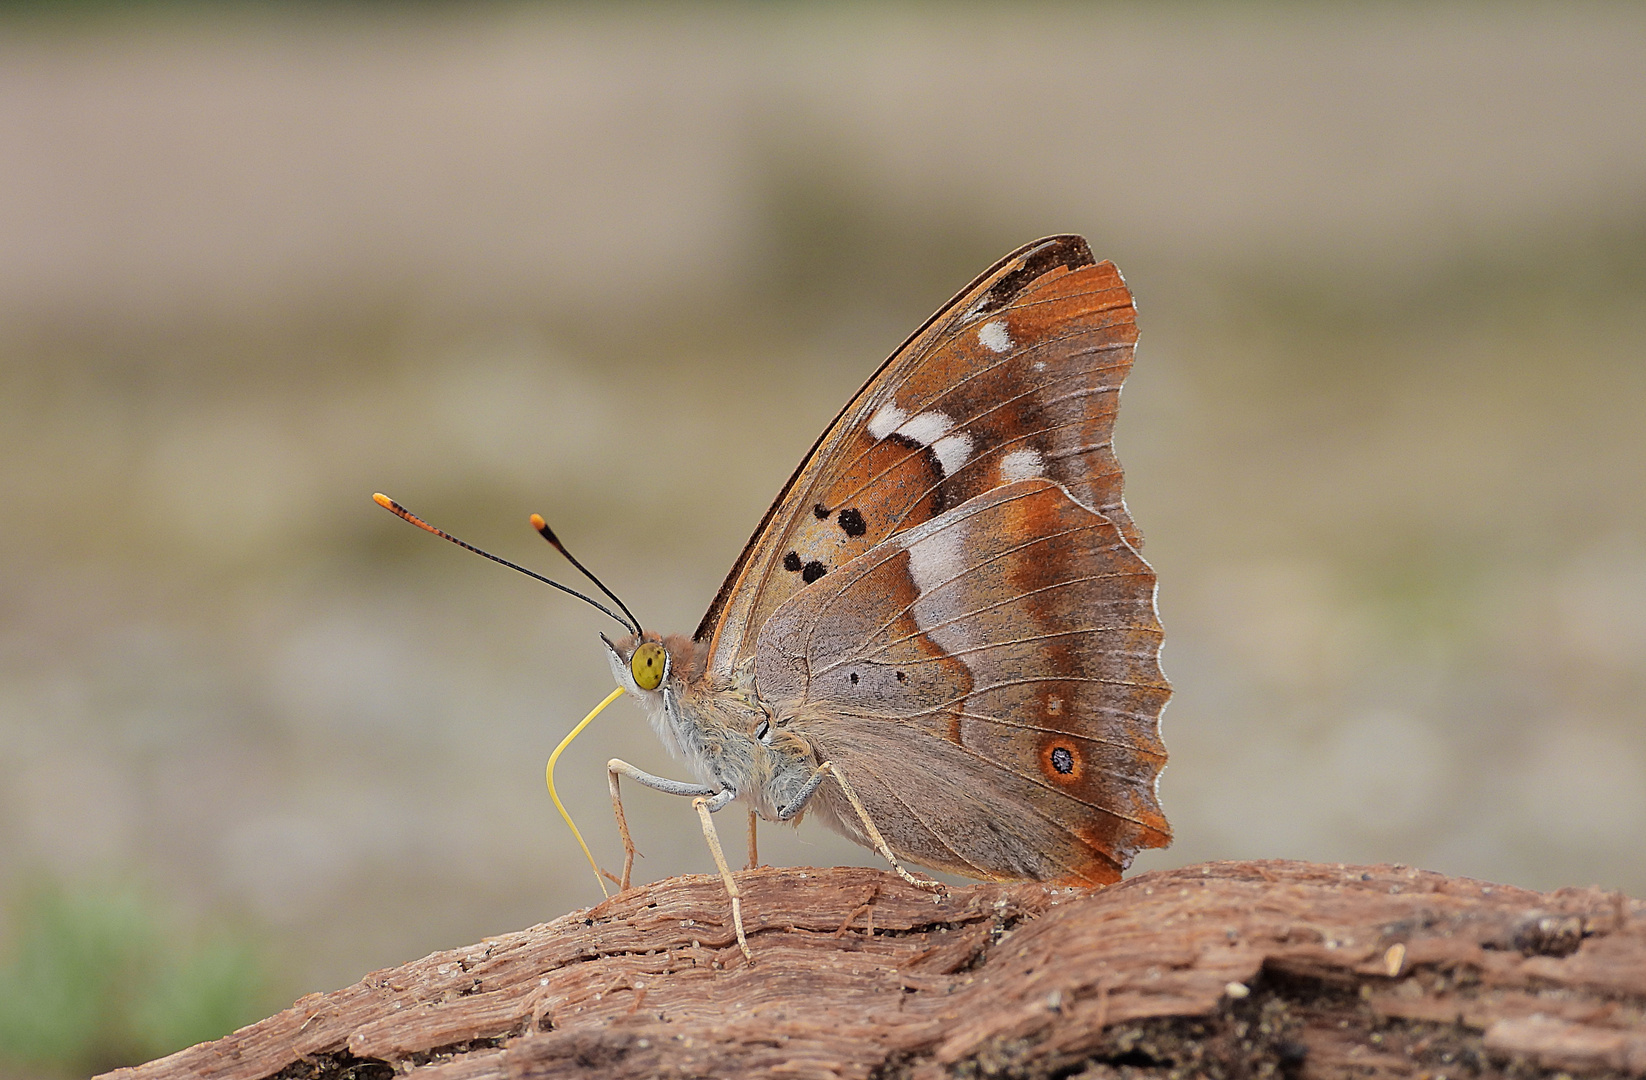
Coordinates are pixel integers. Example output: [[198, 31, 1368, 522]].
[[0, 884, 272, 1077]]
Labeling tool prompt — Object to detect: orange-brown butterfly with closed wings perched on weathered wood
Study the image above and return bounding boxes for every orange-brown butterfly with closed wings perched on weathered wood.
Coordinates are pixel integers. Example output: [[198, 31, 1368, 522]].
[[379, 235, 1170, 955]]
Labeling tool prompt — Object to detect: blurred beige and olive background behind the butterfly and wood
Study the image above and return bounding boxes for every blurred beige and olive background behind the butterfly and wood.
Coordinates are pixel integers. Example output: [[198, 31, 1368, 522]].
[[0, 2, 1646, 1075]]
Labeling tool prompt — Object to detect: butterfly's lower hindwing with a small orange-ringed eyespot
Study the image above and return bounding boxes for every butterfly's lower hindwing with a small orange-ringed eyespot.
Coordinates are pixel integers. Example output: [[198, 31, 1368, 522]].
[[756, 477, 1170, 884]]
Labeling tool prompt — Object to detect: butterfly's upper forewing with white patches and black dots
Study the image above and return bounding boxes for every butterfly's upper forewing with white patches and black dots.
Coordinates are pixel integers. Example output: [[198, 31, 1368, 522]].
[[693, 235, 1141, 682]]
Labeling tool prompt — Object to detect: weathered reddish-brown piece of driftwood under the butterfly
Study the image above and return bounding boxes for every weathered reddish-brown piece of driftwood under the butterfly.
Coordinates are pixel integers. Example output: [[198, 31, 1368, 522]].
[[107, 863, 1646, 1080]]
